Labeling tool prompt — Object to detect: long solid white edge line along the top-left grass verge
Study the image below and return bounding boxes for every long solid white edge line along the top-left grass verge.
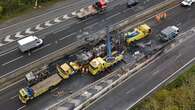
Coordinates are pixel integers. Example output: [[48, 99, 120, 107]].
[[0, 0, 86, 31]]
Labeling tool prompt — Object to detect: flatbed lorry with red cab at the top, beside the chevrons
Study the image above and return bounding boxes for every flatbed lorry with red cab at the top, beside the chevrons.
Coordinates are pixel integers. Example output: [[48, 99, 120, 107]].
[[76, 0, 107, 19]]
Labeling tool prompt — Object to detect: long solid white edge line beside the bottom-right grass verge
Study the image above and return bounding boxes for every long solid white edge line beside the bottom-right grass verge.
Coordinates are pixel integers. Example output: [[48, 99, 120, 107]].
[[127, 57, 195, 110]]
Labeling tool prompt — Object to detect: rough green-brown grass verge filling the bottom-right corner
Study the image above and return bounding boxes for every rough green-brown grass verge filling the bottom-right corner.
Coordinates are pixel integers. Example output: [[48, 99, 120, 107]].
[[132, 65, 195, 110]]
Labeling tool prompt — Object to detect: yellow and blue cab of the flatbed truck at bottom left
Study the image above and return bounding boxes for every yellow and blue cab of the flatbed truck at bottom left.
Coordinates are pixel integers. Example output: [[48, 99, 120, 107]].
[[19, 88, 33, 104]]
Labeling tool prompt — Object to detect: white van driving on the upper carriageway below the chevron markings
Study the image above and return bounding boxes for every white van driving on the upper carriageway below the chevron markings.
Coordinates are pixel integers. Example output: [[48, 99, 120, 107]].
[[18, 36, 43, 52]]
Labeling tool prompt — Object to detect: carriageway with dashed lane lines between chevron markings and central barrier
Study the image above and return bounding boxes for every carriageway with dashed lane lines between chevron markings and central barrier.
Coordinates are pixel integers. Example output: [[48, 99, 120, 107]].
[[0, 0, 165, 77]]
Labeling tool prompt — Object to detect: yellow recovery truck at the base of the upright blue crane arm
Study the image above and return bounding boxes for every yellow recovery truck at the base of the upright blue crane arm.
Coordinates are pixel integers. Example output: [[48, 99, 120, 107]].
[[89, 52, 123, 75]]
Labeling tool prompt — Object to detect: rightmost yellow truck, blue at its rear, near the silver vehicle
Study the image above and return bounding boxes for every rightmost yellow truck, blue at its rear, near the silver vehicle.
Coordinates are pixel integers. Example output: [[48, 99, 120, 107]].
[[125, 24, 151, 44]]
